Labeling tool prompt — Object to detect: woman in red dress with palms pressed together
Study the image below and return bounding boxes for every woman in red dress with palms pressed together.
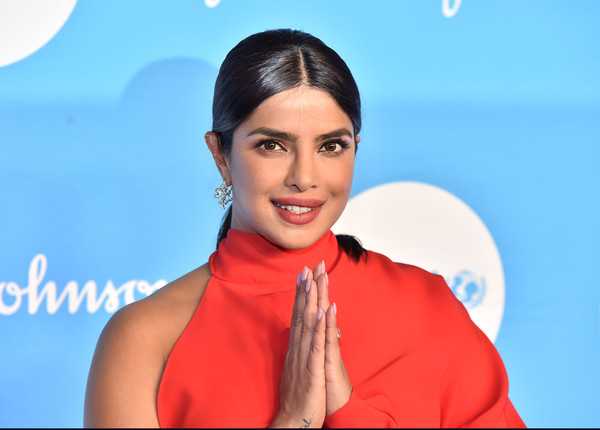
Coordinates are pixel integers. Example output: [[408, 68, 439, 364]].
[[85, 29, 525, 427]]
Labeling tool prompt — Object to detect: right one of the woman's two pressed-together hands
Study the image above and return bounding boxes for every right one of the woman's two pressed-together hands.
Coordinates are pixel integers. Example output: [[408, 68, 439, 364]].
[[314, 261, 352, 415]]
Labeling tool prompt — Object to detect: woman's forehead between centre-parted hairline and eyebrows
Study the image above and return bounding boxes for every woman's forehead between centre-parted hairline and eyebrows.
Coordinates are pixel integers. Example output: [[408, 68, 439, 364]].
[[236, 86, 352, 136]]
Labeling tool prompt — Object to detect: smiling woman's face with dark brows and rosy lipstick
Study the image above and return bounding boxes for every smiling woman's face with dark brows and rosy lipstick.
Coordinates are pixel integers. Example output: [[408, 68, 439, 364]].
[[211, 86, 359, 249]]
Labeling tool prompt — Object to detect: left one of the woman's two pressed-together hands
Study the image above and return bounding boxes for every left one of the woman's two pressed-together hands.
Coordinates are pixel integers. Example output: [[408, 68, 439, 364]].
[[272, 267, 327, 428]]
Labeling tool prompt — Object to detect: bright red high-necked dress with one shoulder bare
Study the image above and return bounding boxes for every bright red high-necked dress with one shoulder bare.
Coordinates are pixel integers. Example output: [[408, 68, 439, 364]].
[[156, 229, 525, 428]]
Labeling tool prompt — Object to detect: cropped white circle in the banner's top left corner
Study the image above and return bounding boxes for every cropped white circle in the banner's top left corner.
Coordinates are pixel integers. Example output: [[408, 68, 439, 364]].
[[0, 0, 77, 67]]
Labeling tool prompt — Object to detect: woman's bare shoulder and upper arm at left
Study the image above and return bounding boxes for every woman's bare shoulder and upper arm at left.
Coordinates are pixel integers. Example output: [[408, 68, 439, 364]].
[[84, 263, 210, 427]]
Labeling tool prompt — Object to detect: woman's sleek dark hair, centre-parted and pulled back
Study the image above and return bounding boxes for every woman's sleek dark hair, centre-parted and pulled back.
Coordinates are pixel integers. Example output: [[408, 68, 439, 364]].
[[212, 29, 366, 261]]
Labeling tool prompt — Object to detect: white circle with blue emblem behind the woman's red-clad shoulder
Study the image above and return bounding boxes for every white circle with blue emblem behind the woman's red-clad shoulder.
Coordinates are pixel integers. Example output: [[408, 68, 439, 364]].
[[332, 182, 504, 342]]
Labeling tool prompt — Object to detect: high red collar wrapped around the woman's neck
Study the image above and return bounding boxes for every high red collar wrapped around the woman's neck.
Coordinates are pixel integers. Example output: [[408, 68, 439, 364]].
[[209, 228, 340, 293]]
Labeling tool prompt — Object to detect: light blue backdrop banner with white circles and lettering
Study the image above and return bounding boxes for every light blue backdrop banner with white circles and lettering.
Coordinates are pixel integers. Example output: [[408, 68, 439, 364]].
[[0, 0, 600, 427]]
